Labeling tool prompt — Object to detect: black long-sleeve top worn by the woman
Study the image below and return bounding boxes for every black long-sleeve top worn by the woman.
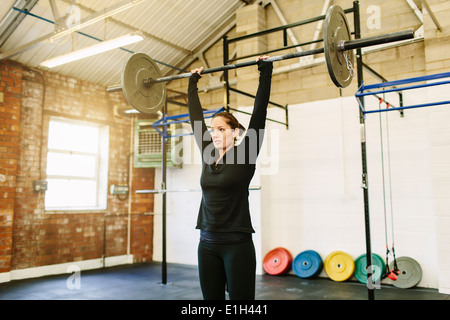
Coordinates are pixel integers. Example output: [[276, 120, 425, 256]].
[[188, 60, 273, 238]]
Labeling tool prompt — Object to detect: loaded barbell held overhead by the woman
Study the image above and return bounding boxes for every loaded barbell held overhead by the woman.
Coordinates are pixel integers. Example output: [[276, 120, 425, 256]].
[[107, 5, 414, 114]]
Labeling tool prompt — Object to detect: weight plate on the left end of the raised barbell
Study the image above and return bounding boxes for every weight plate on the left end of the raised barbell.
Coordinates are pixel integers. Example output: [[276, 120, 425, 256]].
[[122, 53, 166, 114]]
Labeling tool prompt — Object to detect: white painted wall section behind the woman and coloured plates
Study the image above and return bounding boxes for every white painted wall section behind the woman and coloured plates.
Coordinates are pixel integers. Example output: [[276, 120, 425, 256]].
[[154, 86, 450, 293]]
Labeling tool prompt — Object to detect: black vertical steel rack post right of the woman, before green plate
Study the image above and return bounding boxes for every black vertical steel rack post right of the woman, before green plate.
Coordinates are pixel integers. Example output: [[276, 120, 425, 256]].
[[353, 1, 375, 300]]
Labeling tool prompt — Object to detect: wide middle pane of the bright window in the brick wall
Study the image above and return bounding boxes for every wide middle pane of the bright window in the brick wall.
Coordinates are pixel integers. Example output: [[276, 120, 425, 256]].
[[47, 152, 96, 178]]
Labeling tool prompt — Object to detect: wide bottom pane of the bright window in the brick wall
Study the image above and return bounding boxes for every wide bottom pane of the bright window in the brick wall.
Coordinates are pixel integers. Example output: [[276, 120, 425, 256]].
[[45, 179, 97, 208]]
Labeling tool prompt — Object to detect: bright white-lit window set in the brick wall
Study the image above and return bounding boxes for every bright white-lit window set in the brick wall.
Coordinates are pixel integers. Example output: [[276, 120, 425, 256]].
[[45, 117, 109, 210]]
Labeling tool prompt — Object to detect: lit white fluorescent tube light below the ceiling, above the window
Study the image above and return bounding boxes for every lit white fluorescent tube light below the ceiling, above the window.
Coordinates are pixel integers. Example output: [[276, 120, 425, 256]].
[[41, 33, 144, 68]]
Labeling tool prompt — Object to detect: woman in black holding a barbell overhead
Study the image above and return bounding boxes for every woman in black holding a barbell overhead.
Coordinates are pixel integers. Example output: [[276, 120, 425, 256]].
[[188, 56, 272, 300]]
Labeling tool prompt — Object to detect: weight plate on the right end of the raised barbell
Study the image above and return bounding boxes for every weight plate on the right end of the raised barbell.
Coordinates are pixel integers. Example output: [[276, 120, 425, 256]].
[[323, 5, 353, 88]]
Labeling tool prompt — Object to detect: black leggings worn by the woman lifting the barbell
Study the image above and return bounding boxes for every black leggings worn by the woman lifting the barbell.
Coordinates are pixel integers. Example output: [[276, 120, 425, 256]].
[[198, 240, 256, 300]]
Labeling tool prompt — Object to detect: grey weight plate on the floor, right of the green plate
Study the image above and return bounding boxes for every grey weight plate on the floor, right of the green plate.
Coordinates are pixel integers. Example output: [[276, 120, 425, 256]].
[[389, 257, 422, 289]]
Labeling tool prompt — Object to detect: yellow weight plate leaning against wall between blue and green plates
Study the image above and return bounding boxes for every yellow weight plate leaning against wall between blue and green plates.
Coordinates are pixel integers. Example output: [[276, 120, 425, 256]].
[[323, 251, 355, 281]]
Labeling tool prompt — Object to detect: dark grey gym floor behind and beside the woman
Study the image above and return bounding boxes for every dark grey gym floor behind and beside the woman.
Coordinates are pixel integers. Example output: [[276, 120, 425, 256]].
[[0, 262, 450, 300]]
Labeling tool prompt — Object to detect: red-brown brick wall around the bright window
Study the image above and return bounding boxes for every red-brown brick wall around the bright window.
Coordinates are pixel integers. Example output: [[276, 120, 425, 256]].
[[0, 61, 154, 272]]
